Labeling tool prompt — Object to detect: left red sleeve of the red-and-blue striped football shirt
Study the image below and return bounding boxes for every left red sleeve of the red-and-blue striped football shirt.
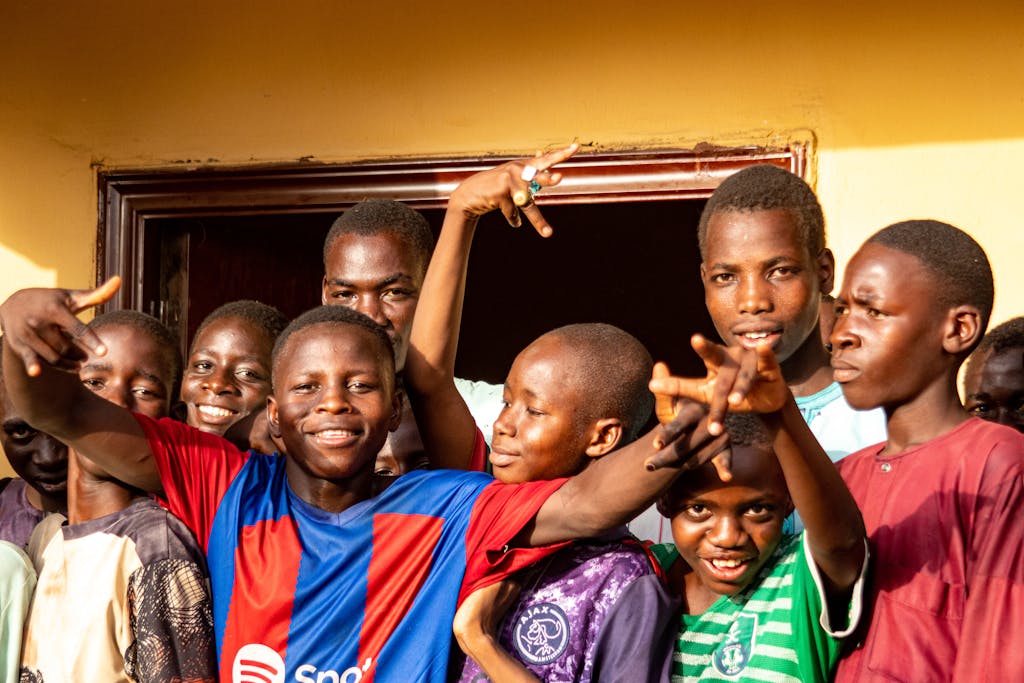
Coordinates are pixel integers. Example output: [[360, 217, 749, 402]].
[[135, 414, 249, 551]]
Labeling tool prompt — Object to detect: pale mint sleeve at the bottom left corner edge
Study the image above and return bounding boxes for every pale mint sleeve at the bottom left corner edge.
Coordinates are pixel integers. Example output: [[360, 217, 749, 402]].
[[0, 541, 36, 681]]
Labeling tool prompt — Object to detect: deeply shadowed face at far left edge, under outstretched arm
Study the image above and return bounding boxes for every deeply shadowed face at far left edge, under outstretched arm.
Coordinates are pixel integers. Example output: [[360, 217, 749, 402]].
[[0, 376, 68, 500]]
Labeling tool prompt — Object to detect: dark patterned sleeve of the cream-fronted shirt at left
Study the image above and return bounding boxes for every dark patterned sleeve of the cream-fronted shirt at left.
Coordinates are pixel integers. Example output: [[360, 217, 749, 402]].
[[125, 559, 217, 683]]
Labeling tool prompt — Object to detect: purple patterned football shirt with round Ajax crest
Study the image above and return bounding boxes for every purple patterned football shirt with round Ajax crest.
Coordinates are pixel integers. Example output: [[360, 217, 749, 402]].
[[459, 540, 676, 683]]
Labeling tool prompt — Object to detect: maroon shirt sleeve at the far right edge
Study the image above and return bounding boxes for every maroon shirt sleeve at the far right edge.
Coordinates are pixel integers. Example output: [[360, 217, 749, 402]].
[[952, 440, 1024, 681]]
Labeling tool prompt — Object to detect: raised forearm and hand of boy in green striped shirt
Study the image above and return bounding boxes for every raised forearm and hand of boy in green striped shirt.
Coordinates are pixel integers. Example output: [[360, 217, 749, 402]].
[[651, 336, 864, 595]]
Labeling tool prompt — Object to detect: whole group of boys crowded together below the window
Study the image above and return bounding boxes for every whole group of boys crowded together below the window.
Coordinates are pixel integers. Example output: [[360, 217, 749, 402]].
[[0, 146, 1024, 681]]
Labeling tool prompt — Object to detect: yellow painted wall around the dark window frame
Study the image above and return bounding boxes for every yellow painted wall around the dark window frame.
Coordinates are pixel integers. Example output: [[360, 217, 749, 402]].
[[0, 0, 1024, 473]]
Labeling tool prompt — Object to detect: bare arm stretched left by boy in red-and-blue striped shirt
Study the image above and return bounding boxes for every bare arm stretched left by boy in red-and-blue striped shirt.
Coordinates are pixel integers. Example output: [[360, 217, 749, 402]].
[[0, 278, 161, 492]]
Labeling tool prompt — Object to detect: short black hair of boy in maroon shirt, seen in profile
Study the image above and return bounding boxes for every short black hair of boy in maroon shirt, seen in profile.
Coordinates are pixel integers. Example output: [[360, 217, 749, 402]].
[[864, 219, 995, 337]]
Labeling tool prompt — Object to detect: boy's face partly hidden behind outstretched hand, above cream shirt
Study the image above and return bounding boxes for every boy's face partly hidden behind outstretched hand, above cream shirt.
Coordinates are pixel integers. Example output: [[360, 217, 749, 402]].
[[79, 325, 175, 419]]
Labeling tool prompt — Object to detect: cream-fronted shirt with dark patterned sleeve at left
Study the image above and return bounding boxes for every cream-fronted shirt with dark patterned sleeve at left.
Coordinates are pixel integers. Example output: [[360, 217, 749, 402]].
[[22, 498, 216, 683]]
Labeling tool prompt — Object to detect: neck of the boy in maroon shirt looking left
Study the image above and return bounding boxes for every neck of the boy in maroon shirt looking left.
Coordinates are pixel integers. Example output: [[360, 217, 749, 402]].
[[882, 372, 969, 456]]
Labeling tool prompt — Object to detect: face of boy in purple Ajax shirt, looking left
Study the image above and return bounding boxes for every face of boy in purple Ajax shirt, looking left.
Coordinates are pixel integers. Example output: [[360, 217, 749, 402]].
[[490, 336, 591, 483]]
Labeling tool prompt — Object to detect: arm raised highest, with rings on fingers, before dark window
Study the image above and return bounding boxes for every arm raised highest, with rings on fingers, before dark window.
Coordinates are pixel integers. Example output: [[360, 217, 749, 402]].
[[404, 144, 578, 469]]
